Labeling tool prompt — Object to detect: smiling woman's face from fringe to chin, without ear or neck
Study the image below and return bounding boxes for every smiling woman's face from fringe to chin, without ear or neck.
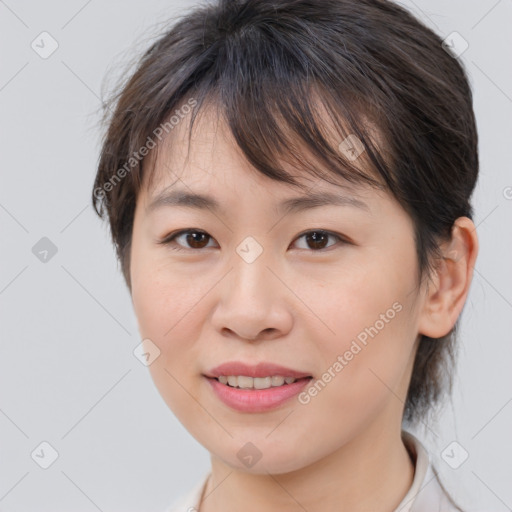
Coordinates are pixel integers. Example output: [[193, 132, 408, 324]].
[[130, 110, 422, 473]]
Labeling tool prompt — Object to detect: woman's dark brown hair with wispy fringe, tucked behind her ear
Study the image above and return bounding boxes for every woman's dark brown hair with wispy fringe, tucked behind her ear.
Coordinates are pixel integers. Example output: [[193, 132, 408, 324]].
[[92, 0, 478, 422]]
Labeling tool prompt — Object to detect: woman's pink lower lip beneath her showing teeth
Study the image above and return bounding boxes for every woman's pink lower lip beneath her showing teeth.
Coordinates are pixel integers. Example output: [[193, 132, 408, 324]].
[[206, 377, 311, 412]]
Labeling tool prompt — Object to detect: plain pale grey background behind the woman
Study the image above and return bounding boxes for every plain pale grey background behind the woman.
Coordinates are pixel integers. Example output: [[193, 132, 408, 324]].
[[0, 0, 512, 512]]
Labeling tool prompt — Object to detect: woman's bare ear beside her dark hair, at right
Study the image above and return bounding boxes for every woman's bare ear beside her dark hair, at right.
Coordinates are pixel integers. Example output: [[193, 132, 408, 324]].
[[418, 217, 478, 338]]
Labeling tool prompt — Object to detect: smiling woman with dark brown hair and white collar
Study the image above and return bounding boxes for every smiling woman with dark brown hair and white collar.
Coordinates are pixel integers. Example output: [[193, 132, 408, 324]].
[[93, 0, 478, 512]]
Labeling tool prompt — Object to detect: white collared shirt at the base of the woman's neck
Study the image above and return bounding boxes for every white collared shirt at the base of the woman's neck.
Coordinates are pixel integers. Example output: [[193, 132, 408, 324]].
[[165, 431, 462, 512]]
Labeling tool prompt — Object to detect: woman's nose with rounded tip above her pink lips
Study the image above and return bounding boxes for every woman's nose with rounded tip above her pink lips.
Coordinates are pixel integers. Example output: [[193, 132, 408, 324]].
[[212, 251, 293, 341]]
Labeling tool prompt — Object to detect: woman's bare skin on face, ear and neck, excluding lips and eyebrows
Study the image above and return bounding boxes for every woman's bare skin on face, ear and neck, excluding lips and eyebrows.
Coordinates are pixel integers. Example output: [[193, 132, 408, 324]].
[[130, 105, 478, 512]]
